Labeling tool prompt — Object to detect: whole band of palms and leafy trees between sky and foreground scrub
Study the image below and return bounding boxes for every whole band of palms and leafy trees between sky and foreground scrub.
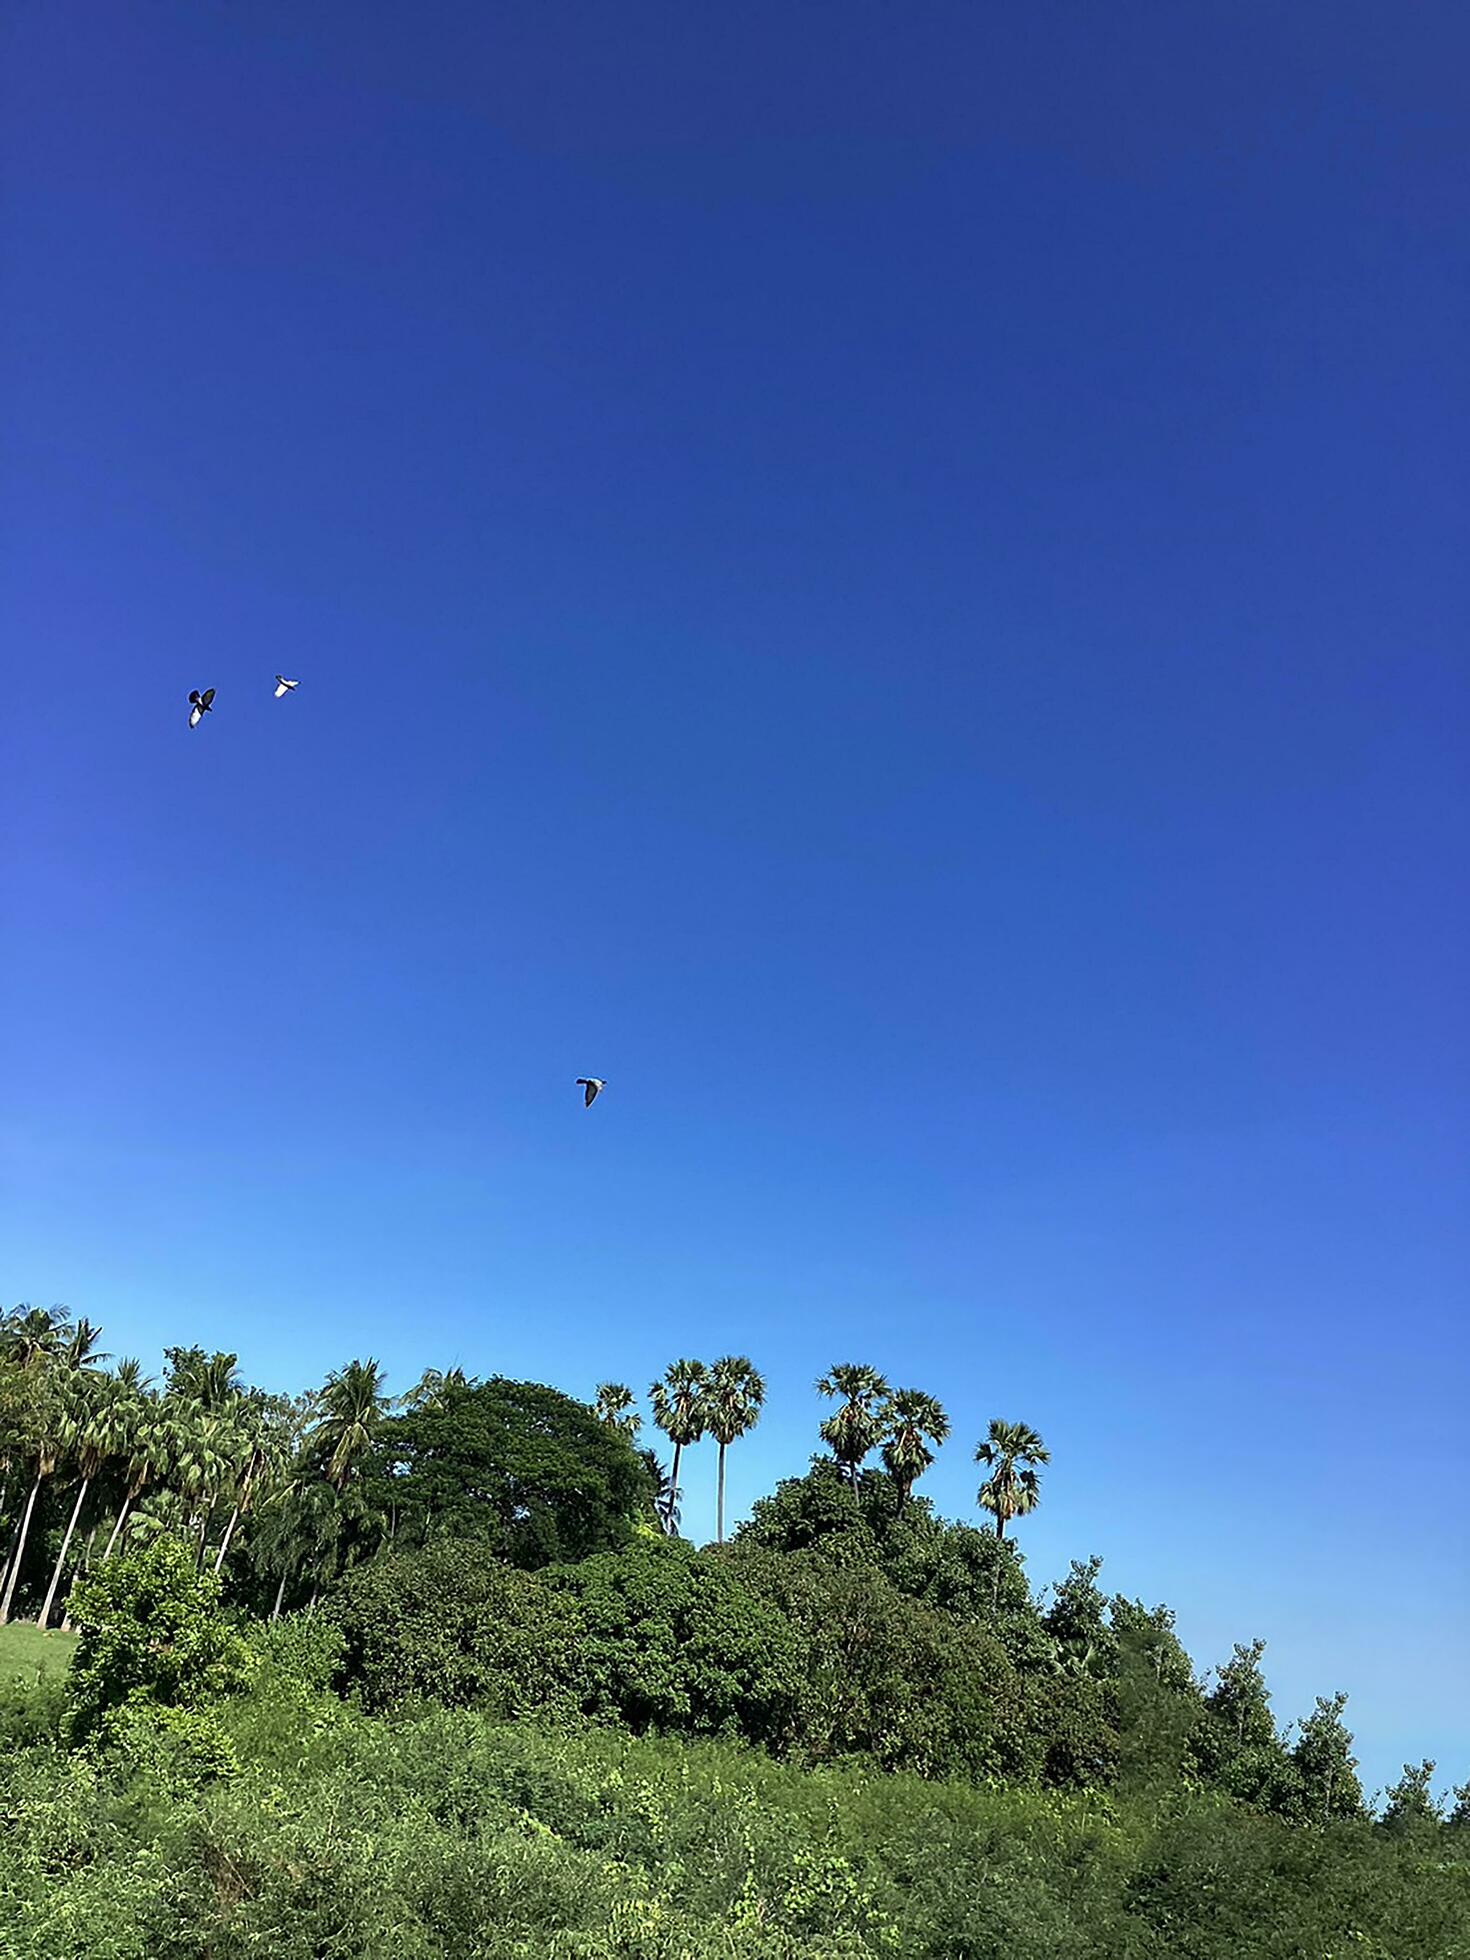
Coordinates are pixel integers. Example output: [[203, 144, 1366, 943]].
[[0, 1307, 1470, 1835]]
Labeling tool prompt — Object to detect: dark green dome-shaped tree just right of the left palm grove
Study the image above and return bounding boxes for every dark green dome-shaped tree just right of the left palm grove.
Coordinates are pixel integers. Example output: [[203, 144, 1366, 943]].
[[365, 1380, 653, 1568]]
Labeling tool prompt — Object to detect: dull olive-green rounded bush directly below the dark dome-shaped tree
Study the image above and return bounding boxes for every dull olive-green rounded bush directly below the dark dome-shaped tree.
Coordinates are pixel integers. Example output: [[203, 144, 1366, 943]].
[[323, 1541, 578, 1715]]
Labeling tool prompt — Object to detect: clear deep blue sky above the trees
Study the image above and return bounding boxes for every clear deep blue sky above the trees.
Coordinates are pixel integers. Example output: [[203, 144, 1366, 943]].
[[0, 0, 1470, 1784]]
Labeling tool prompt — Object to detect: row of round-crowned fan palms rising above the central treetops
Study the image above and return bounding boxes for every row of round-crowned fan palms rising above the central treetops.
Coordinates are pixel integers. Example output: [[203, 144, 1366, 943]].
[[594, 1354, 1051, 1544]]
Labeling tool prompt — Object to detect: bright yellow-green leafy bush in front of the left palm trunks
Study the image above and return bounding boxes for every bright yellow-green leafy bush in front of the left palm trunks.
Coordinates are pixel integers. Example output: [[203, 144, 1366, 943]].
[[67, 1537, 255, 1742]]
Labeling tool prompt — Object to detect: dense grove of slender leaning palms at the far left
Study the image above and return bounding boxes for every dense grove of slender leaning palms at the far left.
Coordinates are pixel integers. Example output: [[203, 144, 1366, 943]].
[[0, 1307, 388, 1627]]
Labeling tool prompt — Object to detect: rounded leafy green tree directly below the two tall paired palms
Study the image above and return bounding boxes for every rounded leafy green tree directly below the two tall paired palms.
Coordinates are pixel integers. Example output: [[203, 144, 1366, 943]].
[[547, 1541, 798, 1742]]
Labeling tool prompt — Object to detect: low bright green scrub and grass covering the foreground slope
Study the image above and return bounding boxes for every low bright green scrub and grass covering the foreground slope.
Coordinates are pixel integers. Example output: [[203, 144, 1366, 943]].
[[0, 1670, 1470, 1960]]
